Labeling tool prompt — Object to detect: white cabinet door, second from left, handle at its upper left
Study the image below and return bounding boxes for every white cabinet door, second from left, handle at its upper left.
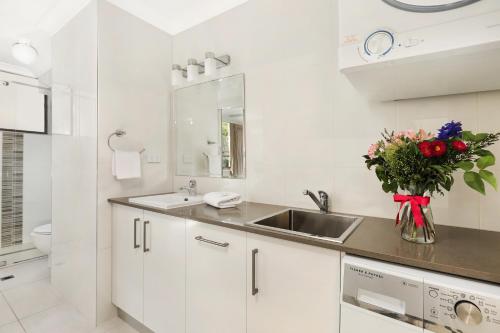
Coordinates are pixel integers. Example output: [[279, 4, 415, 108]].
[[143, 211, 186, 333]]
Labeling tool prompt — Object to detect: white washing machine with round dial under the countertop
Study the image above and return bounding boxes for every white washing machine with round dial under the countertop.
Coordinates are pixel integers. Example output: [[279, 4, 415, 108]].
[[340, 255, 500, 333]]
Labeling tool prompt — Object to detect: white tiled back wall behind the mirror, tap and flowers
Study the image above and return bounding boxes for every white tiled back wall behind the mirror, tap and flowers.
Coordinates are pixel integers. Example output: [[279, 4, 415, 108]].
[[173, 0, 500, 231]]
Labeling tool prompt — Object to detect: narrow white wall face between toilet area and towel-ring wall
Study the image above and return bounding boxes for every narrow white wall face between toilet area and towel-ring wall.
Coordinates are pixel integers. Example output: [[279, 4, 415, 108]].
[[52, 0, 97, 323]]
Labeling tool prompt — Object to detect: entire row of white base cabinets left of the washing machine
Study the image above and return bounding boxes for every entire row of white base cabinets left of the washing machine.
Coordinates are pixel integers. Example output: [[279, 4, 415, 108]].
[[112, 205, 346, 333]]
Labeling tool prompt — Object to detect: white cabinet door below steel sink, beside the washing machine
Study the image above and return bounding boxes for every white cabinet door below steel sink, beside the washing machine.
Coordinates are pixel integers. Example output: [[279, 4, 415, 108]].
[[247, 233, 340, 333]]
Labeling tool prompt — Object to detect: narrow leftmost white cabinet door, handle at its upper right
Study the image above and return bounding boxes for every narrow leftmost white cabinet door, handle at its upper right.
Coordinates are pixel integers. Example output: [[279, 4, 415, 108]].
[[112, 205, 143, 321]]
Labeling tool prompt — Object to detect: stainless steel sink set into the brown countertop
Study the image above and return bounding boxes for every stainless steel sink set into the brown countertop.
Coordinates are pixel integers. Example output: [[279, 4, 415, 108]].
[[251, 209, 363, 243]]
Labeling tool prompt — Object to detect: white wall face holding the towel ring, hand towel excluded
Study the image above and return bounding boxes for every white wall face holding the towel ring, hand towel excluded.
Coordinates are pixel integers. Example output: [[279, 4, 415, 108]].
[[97, 1, 172, 322]]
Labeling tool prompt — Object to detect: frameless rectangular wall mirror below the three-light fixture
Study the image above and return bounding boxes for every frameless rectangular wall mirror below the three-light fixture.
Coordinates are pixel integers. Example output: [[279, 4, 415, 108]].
[[174, 74, 246, 178]]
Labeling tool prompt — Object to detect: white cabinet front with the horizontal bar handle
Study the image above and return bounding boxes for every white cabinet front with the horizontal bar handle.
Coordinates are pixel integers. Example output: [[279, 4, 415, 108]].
[[186, 220, 246, 333]]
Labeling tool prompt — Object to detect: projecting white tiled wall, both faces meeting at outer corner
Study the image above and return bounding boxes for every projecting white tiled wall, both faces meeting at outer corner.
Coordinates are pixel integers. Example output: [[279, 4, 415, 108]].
[[52, 1, 172, 324]]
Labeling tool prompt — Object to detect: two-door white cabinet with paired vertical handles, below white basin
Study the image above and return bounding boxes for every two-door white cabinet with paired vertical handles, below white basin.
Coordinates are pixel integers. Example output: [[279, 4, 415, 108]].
[[112, 205, 186, 333]]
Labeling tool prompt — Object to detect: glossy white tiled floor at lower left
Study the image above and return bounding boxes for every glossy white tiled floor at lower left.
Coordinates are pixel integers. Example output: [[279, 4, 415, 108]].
[[0, 260, 137, 333]]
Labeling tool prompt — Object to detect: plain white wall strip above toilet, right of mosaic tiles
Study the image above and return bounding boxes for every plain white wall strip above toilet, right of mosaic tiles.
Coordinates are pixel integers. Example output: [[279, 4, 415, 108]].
[[23, 133, 52, 243]]
